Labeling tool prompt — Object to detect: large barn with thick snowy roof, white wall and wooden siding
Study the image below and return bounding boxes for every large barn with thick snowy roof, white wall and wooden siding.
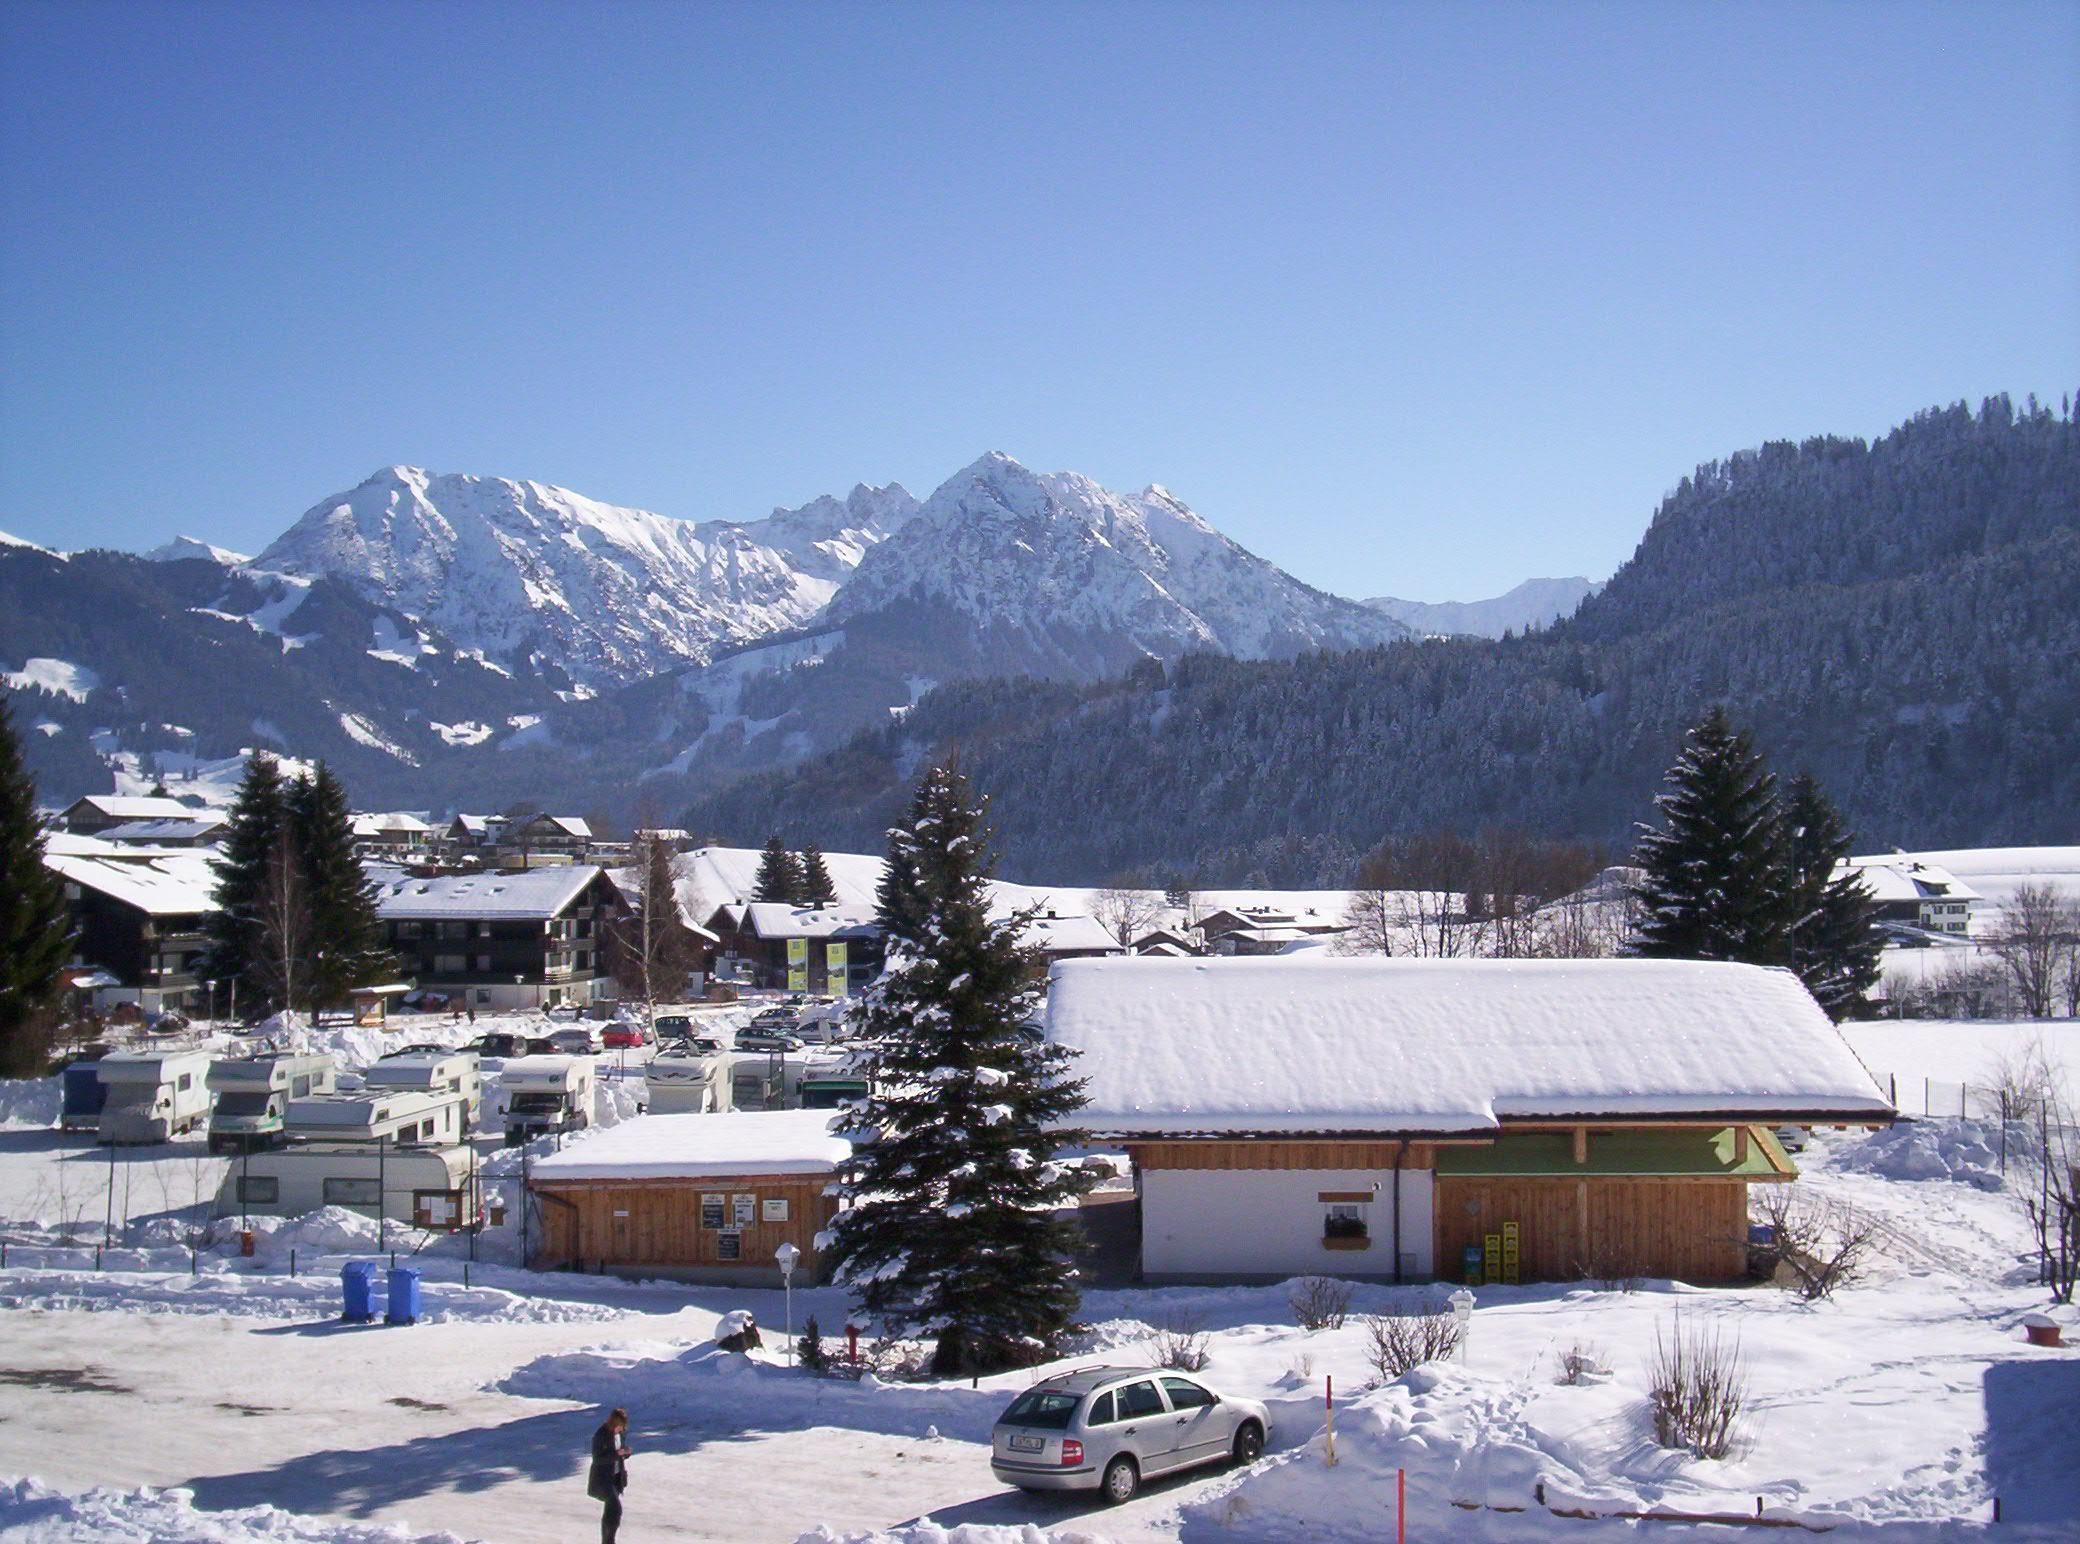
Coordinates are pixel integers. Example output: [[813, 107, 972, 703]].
[[1048, 955, 1893, 1282]]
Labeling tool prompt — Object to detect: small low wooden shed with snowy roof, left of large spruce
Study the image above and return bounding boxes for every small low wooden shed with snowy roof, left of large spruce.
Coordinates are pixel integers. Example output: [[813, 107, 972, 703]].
[[528, 1109, 851, 1286]]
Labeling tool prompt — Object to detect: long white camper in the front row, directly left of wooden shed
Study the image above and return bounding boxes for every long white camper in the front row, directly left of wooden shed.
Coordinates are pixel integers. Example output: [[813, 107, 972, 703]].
[[216, 1142, 480, 1230]]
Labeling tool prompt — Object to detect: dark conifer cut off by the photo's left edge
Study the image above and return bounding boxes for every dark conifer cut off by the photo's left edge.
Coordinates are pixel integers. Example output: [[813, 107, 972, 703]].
[[0, 693, 73, 1078]]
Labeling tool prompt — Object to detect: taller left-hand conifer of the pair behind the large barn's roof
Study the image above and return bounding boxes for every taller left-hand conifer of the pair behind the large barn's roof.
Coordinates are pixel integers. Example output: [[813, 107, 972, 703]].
[[1627, 707, 1791, 966]]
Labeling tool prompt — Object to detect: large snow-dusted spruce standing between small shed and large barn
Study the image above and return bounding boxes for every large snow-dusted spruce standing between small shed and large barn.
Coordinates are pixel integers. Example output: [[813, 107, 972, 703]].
[[832, 768, 1084, 1373]]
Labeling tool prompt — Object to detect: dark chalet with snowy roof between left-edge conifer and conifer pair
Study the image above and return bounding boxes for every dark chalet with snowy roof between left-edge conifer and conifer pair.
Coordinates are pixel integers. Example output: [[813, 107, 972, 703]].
[[44, 839, 216, 1013]]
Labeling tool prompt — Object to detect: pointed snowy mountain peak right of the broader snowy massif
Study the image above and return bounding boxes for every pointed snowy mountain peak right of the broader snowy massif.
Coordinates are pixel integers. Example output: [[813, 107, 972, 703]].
[[822, 452, 1408, 678]]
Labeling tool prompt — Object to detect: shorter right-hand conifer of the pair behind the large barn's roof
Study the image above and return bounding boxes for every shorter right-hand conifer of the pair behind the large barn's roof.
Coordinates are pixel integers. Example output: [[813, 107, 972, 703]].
[[1783, 774, 1884, 1022]]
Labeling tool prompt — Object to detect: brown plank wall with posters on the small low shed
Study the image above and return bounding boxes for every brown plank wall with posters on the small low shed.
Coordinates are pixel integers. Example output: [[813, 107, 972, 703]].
[[535, 1174, 838, 1282]]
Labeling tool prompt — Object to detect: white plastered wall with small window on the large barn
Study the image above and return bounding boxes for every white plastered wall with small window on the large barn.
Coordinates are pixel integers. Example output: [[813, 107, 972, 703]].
[[1140, 1169, 1435, 1278]]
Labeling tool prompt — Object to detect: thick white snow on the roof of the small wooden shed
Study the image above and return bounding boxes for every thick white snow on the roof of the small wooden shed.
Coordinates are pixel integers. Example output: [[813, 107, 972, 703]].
[[535, 1109, 853, 1182]]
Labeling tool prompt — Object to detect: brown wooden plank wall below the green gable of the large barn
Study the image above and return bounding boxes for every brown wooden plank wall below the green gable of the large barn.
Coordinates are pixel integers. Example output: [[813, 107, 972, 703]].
[[1437, 1178, 1747, 1282]]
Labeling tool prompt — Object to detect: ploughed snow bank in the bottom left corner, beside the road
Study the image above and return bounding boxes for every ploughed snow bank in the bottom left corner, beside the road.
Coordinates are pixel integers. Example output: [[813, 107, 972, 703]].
[[0, 1479, 462, 1544]]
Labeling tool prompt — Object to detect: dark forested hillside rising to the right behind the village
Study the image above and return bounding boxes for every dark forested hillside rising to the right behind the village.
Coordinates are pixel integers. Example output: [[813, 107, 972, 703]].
[[686, 397, 2080, 884]]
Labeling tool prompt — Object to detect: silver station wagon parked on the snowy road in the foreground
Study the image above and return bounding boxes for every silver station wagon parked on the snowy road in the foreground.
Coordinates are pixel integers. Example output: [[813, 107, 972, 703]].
[[990, 1367, 1271, 1504]]
